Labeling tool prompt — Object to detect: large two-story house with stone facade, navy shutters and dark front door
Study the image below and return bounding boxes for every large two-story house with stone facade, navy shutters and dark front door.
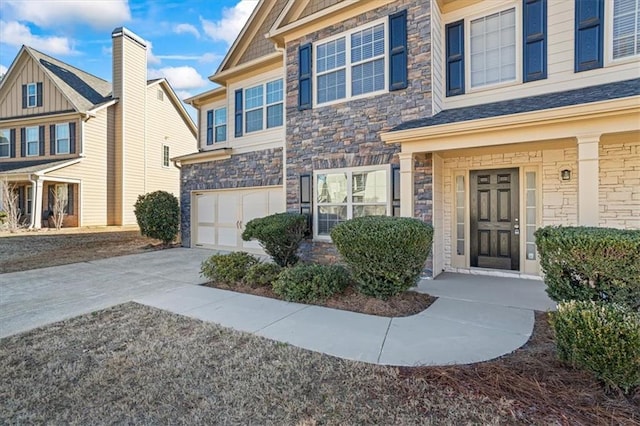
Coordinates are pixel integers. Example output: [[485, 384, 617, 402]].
[[179, 0, 640, 276]]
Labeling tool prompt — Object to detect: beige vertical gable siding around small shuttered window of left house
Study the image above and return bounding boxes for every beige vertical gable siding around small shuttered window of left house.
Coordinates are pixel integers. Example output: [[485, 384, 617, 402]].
[[0, 55, 73, 119]]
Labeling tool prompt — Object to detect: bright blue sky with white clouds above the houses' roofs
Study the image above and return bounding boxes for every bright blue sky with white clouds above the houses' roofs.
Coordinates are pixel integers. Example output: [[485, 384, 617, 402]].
[[0, 0, 258, 115]]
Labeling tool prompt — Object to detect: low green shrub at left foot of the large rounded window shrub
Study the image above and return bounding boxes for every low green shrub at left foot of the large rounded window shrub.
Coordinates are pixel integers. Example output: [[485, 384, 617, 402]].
[[273, 264, 349, 303]]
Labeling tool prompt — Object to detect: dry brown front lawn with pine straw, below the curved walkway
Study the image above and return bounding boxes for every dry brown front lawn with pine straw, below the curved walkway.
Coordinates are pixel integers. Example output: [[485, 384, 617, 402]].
[[0, 303, 640, 425]]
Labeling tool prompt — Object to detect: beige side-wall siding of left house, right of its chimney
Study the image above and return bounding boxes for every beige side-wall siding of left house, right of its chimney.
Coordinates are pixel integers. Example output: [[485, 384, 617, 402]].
[[146, 84, 197, 197]]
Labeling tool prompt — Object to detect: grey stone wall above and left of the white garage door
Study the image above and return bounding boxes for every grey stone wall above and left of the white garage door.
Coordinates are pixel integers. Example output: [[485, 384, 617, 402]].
[[180, 148, 282, 247]]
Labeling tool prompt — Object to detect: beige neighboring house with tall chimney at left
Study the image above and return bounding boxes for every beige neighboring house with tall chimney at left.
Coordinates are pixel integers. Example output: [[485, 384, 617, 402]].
[[0, 28, 197, 228]]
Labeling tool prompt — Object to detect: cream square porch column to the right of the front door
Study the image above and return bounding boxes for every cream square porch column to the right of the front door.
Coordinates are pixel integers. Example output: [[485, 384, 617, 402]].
[[577, 134, 600, 226]]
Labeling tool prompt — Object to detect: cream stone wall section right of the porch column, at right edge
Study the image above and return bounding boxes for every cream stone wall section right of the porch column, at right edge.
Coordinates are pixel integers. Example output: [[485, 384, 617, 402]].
[[599, 138, 640, 229]]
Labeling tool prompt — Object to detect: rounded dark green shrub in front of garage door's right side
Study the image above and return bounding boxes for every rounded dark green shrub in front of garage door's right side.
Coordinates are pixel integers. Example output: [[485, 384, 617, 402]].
[[242, 213, 307, 266]]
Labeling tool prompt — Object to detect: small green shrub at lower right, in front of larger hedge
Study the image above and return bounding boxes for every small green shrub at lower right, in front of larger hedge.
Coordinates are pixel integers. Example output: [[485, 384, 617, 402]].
[[551, 300, 640, 393]]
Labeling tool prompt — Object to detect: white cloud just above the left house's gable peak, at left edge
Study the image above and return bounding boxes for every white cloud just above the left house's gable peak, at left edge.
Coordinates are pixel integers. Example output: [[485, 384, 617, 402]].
[[0, 21, 78, 55]]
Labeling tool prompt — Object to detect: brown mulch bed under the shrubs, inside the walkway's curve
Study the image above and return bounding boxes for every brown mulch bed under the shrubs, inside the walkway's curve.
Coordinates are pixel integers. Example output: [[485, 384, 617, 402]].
[[203, 282, 436, 317]]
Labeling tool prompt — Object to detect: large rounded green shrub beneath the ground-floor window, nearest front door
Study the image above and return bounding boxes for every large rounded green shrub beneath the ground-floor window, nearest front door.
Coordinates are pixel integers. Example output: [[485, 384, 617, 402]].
[[331, 216, 433, 299]]
